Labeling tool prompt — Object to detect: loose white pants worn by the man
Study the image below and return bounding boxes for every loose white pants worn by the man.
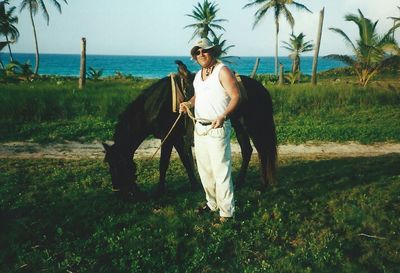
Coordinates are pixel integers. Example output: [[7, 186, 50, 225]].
[[194, 121, 235, 217]]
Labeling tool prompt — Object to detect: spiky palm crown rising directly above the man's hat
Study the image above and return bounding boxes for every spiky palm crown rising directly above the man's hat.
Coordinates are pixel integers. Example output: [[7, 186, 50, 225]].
[[185, 0, 227, 41]]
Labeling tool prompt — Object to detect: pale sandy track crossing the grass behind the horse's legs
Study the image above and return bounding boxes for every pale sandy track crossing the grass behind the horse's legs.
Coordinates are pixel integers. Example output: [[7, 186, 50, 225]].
[[0, 139, 400, 159]]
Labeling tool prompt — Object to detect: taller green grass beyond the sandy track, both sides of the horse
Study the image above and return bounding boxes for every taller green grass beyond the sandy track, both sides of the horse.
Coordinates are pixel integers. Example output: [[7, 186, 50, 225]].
[[0, 79, 400, 144]]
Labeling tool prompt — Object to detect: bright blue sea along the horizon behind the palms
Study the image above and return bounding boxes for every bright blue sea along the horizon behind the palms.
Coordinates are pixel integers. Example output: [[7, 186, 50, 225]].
[[0, 52, 344, 78]]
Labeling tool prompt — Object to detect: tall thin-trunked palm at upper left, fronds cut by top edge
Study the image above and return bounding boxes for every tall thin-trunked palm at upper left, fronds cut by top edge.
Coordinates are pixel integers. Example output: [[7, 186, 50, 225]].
[[20, 0, 68, 75]]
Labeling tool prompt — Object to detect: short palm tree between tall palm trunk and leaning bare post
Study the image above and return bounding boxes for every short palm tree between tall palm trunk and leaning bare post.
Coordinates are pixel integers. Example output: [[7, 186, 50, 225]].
[[282, 32, 314, 75]]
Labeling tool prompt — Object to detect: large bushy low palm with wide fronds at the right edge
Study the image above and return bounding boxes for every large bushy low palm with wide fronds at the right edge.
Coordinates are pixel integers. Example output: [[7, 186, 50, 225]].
[[325, 10, 400, 86]]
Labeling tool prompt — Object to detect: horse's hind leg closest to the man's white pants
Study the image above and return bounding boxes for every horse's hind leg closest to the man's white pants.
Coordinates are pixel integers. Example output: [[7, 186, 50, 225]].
[[232, 121, 253, 188]]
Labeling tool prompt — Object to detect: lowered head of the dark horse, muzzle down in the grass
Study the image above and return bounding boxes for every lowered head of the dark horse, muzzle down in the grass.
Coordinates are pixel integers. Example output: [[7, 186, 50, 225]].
[[103, 143, 137, 193]]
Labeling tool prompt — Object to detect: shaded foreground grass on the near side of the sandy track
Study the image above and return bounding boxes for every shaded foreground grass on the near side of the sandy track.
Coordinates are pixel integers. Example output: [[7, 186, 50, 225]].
[[0, 155, 400, 273]]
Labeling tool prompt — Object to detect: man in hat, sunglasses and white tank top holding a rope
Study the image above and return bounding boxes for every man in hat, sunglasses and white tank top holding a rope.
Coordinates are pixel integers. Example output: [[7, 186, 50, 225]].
[[180, 38, 240, 222]]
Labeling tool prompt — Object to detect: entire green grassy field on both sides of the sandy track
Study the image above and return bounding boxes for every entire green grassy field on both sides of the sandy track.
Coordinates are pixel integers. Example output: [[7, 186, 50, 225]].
[[0, 71, 400, 273]]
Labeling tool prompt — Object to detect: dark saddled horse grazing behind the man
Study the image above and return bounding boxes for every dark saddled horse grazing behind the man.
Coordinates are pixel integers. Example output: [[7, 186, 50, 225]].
[[103, 61, 277, 194]]
